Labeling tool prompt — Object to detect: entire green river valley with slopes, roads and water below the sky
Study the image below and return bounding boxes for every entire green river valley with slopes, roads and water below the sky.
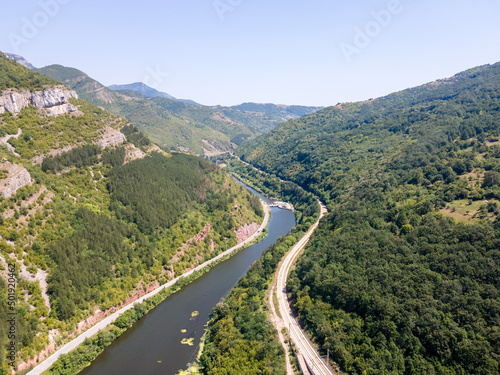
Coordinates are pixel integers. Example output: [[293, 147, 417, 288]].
[[0, 33, 500, 375]]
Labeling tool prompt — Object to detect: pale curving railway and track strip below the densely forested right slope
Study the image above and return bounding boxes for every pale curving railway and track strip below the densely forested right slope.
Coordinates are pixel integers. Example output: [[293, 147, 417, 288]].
[[276, 201, 334, 375]]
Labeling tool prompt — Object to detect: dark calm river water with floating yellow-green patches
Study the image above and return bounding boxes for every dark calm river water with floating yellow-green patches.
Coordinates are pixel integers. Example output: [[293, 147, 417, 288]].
[[80, 183, 295, 375]]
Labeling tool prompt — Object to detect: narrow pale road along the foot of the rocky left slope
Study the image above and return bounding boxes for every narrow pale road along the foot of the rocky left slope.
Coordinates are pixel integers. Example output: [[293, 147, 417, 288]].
[[28, 200, 270, 375]]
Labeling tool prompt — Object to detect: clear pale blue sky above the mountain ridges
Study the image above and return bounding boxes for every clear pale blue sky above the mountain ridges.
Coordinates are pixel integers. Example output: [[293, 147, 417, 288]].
[[0, 0, 500, 106]]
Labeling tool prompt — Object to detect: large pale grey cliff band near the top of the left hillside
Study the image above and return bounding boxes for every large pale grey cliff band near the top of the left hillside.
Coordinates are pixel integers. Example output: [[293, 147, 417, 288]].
[[0, 86, 78, 116]]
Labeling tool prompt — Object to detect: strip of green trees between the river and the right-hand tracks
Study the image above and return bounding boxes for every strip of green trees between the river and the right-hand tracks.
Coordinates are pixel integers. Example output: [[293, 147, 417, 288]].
[[200, 157, 319, 375]]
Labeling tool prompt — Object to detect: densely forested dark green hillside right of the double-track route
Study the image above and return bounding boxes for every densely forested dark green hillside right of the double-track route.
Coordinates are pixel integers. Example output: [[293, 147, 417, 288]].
[[237, 63, 500, 374]]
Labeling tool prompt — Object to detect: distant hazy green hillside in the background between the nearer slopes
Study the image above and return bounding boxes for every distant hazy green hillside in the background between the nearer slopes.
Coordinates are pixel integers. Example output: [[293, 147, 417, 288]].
[[37, 65, 318, 156]]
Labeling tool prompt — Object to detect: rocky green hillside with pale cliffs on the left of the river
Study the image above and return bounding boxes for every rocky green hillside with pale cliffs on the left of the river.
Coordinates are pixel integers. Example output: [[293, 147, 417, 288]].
[[0, 53, 262, 374]]
